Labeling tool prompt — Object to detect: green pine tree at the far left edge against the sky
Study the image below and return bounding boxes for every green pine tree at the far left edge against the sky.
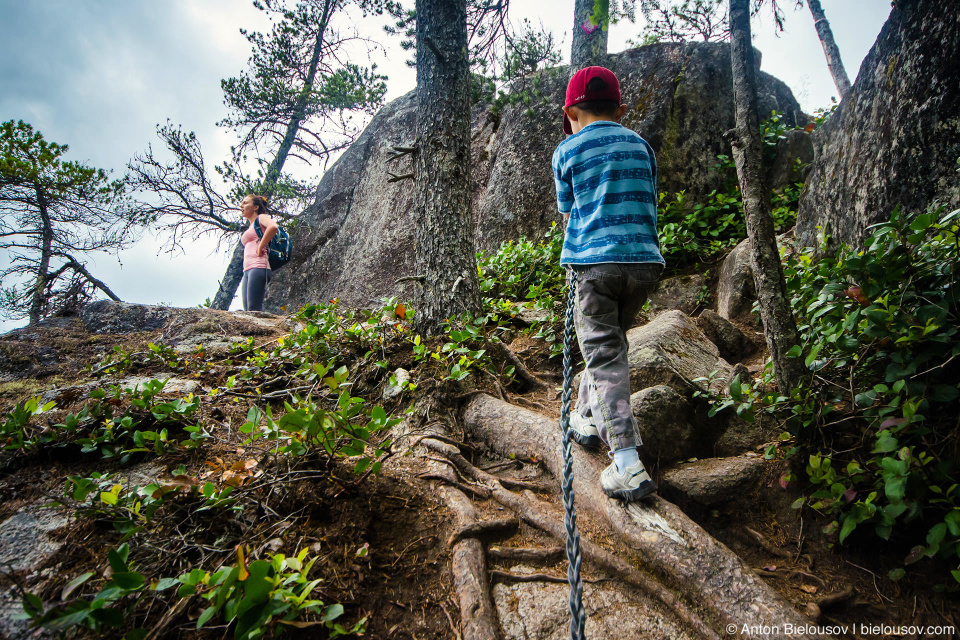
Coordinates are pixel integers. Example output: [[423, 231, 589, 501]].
[[0, 120, 146, 324]]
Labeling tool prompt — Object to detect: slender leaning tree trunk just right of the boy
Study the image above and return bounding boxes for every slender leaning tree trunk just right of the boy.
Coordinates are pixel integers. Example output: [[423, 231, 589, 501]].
[[730, 0, 803, 395]]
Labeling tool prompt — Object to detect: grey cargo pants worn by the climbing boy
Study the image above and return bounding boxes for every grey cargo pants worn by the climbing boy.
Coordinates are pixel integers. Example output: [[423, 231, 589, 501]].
[[571, 263, 663, 451]]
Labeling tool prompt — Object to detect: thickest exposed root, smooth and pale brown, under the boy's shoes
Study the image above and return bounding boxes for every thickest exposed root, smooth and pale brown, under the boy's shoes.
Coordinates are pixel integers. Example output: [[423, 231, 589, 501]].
[[462, 395, 823, 638]]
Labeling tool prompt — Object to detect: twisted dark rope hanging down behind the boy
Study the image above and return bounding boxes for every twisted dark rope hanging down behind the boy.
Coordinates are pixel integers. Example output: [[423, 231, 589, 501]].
[[560, 269, 587, 640]]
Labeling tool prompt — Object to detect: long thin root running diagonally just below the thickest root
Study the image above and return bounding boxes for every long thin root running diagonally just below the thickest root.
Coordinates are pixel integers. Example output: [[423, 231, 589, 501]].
[[423, 439, 719, 640]]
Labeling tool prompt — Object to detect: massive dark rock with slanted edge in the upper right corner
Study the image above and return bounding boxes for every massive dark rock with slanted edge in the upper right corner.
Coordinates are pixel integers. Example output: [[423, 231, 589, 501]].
[[797, 0, 960, 246]]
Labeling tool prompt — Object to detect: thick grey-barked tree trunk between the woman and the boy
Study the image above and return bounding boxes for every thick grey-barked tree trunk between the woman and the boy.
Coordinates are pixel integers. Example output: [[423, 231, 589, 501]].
[[414, 0, 480, 335]]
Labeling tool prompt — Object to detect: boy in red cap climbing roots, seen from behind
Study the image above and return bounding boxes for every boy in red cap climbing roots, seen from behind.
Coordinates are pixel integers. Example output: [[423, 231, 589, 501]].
[[553, 67, 664, 502]]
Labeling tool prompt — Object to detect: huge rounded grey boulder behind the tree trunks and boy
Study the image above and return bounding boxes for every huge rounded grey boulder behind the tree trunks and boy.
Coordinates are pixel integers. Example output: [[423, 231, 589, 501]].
[[266, 43, 804, 310]]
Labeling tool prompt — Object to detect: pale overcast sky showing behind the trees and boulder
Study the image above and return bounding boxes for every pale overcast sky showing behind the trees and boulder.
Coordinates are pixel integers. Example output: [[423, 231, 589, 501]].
[[0, 0, 890, 331]]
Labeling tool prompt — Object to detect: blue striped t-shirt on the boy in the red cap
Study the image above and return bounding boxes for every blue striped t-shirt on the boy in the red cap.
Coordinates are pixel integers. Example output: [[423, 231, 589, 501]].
[[553, 120, 664, 264]]
